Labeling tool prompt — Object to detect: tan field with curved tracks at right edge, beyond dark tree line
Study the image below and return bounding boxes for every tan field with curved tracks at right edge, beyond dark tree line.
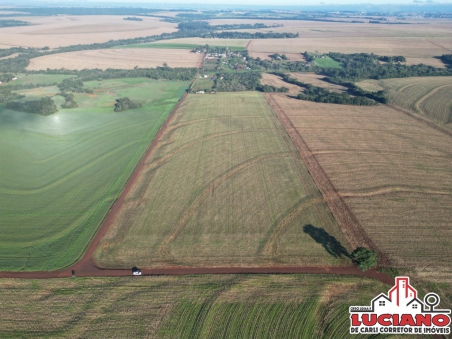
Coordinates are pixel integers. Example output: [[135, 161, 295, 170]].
[[358, 77, 452, 127]]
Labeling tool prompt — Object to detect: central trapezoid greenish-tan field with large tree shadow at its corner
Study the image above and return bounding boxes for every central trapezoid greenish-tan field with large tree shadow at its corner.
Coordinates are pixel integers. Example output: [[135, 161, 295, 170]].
[[94, 92, 350, 268]]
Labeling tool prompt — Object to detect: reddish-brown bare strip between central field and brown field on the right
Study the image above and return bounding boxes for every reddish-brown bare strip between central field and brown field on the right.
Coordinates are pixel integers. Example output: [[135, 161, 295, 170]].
[[264, 94, 389, 265]]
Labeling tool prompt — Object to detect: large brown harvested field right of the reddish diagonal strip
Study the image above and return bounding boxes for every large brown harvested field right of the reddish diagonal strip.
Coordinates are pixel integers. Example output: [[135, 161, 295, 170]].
[[273, 95, 452, 274]]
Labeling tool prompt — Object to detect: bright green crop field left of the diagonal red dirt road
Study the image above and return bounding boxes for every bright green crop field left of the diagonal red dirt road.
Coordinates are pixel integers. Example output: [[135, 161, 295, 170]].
[[0, 78, 188, 271]]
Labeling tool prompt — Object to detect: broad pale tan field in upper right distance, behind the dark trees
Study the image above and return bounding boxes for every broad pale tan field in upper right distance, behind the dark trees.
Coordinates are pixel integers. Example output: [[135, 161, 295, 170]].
[[244, 20, 452, 67]]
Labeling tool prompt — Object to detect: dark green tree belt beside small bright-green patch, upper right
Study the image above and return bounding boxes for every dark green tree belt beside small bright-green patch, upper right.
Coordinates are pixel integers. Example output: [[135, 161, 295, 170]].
[[320, 53, 452, 84]]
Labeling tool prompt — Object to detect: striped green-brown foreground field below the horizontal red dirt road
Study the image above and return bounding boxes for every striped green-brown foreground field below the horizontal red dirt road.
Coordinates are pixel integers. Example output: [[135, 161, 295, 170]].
[[0, 275, 428, 339]]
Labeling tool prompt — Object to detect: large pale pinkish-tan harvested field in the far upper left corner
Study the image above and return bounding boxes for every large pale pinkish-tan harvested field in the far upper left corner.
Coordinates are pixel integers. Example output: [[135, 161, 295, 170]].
[[0, 15, 177, 48]]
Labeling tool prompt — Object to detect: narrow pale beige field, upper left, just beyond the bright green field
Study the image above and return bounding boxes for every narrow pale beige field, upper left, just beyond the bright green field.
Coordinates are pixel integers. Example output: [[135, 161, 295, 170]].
[[27, 48, 202, 70]]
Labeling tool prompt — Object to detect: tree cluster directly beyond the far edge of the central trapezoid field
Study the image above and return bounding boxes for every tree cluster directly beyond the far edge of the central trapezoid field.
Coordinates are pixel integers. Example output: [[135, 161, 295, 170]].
[[214, 72, 262, 92]]
